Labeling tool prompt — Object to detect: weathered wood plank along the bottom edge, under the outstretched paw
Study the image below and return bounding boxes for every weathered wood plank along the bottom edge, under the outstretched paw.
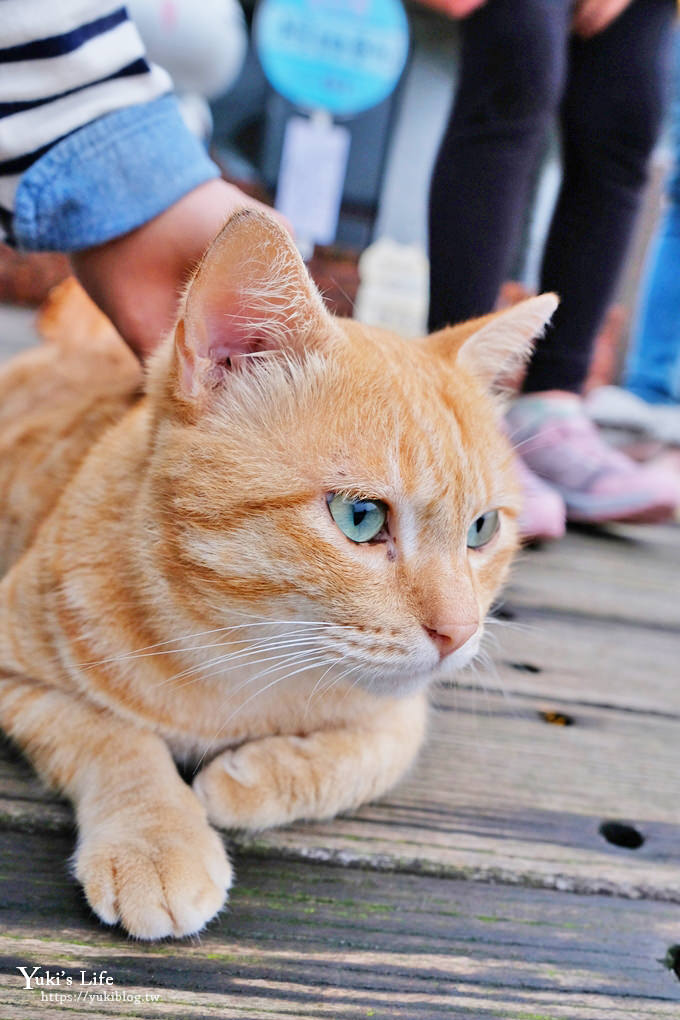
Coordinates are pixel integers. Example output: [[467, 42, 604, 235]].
[[0, 834, 680, 1020]]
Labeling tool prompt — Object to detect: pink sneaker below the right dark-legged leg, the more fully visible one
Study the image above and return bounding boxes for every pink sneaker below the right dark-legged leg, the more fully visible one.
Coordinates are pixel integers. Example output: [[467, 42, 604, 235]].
[[507, 394, 680, 523]]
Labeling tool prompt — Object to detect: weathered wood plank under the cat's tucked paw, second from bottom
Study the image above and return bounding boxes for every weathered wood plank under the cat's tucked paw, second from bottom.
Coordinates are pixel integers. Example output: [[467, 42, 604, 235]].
[[0, 690, 680, 903]]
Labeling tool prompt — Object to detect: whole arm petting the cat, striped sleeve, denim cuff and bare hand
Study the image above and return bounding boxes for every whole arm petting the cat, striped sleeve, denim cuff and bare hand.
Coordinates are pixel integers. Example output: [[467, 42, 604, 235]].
[[0, 0, 285, 354]]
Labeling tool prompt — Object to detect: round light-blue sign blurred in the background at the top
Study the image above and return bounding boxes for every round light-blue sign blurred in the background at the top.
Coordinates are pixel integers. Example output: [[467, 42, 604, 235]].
[[254, 0, 409, 116]]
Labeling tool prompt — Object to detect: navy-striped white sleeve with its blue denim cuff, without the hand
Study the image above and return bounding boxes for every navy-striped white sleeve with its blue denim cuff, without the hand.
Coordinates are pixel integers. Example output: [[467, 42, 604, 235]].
[[0, 0, 210, 251]]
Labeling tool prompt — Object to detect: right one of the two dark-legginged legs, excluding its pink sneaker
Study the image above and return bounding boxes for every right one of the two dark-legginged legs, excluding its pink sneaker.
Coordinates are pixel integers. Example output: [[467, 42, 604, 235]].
[[523, 0, 675, 393]]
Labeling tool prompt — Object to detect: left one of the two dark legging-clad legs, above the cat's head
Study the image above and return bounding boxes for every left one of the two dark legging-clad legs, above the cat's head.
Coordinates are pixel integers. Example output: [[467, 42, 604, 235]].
[[429, 0, 571, 329]]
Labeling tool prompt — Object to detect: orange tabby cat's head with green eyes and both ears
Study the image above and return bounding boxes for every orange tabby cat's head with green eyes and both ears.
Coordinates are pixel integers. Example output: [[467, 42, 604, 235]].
[[149, 211, 557, 693]]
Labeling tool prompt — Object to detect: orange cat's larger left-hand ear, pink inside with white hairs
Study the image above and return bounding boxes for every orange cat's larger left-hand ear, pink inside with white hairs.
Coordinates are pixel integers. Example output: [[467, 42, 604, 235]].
[[170, 209, 329, 403]]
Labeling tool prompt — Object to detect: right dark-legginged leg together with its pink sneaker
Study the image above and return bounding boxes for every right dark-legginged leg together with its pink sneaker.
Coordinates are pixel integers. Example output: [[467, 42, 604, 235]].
[[508, 0, 680, 521]]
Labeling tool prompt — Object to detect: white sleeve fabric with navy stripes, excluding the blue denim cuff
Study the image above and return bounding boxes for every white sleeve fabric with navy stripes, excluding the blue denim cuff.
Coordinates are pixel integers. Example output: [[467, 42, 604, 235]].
[[0, 0, 218, 243]]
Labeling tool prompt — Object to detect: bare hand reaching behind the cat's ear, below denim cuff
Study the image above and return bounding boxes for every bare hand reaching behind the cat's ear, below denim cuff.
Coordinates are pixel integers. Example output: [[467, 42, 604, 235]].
[[71, 180, 287, 357]]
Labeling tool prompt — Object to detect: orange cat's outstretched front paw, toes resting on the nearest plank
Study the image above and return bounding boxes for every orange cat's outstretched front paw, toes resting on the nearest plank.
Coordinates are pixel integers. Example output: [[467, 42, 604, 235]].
[[74, 805, 231, 938]]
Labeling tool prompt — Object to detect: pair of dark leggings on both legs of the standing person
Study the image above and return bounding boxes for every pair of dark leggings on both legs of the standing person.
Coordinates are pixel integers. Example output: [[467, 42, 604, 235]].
[[429, 0, 680, 393]]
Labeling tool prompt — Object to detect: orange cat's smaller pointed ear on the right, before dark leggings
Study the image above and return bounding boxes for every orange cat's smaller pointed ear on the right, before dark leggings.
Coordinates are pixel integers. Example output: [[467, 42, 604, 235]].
[[425, 294, 560, 393]]
